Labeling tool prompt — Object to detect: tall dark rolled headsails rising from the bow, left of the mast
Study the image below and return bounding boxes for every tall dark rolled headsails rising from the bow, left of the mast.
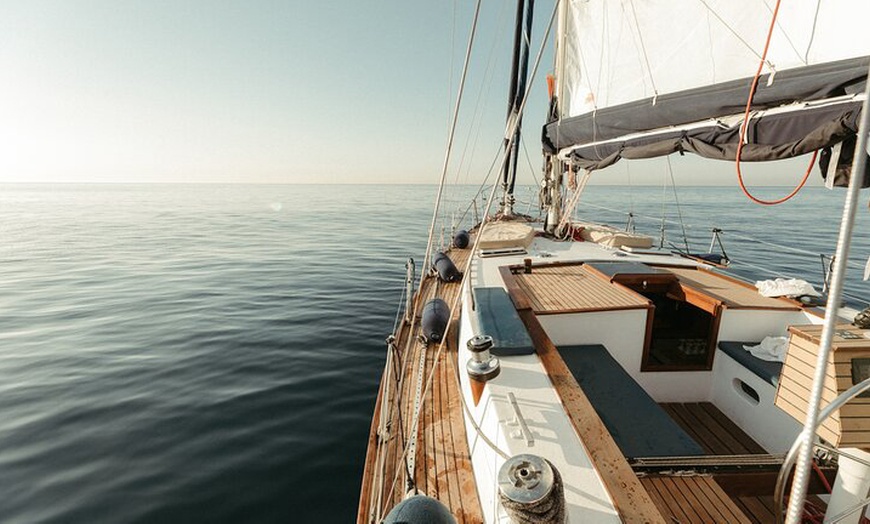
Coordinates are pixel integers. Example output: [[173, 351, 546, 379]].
[[502, 0, 535, 216]]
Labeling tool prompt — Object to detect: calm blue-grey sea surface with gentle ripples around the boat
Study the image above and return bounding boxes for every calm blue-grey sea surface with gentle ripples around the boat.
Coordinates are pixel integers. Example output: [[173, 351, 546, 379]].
[[0, 185, 870, 523]]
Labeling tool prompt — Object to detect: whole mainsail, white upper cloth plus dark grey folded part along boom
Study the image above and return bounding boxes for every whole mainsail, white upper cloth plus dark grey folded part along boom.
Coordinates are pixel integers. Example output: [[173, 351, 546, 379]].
[[543, 0, 870, 169]]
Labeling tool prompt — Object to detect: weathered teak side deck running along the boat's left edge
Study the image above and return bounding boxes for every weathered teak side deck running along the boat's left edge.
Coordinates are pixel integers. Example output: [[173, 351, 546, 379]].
[[357, 250, 483, 524]]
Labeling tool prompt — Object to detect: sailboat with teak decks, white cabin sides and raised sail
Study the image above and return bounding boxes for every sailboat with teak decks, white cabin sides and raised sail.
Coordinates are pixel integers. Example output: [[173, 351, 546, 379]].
[[357, 0, 870, 524]]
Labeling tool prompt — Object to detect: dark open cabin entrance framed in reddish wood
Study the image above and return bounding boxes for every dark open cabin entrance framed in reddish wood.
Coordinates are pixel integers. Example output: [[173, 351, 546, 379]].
[[635, 289, 718, 371]]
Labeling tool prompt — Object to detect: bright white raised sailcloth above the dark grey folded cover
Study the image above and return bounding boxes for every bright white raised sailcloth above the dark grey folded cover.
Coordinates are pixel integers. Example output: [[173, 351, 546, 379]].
[[559, 0, 870, 117]]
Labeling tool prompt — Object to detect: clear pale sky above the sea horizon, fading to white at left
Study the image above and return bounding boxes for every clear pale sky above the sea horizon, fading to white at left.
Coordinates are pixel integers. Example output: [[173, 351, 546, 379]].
[[0, 0, 816, 184]]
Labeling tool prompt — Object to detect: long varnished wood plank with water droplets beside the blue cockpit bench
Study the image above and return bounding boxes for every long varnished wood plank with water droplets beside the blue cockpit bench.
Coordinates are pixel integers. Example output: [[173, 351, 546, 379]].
[[519, 309, 665, 523]]
